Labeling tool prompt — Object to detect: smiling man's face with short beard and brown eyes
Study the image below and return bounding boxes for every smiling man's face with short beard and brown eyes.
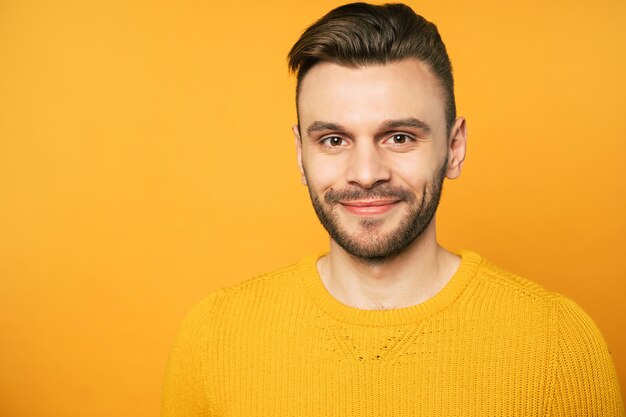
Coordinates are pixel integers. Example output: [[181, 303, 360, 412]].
[[294, 59, 465, 263]]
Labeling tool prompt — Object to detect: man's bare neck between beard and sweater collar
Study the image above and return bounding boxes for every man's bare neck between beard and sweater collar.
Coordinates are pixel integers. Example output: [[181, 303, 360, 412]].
[[317, 219, 460, 310]]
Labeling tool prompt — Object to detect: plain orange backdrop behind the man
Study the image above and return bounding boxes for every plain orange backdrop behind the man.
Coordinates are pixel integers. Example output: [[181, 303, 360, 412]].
[[0, 0, 626, 417]]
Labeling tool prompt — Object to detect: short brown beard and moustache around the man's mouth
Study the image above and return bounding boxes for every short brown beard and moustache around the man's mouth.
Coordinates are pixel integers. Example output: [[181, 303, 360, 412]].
[[304, 158, 448, 265]]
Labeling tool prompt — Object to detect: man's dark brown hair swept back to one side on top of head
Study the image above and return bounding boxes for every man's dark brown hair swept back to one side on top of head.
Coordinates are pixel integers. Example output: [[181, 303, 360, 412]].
[[287, 3, 456, 132]]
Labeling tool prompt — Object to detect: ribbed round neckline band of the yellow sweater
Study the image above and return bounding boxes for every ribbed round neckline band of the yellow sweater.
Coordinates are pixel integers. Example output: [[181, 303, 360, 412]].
[[298, 250, 482, 326]]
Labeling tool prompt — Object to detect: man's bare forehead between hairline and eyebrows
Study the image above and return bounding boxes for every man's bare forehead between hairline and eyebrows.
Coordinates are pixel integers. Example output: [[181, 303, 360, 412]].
[[298, 59, 445, 131]]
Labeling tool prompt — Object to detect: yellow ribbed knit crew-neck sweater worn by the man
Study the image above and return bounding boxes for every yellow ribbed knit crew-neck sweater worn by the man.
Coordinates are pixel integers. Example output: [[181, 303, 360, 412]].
[[163, 252, 624, 417]]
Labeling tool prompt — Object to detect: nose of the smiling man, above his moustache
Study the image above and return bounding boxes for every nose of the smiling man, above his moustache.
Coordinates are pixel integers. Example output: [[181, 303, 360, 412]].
[[346, 141, 391, 189]]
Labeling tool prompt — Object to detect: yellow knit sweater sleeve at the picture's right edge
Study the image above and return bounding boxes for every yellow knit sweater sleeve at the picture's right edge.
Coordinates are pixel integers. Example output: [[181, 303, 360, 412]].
[[548, 297, 624, 417]]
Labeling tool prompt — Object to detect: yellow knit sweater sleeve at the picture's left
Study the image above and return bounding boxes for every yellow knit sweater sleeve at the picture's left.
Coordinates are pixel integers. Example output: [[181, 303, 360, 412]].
[[161, 293, 222, 417]]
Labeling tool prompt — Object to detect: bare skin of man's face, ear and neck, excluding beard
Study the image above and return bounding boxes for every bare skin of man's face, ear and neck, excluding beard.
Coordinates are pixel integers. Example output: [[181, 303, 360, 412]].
[[292, 59, 467, 310]]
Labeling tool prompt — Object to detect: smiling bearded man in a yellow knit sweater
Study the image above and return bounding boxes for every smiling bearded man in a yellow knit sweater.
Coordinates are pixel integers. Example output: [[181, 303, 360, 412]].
[[163, 3, 624, 417]]
